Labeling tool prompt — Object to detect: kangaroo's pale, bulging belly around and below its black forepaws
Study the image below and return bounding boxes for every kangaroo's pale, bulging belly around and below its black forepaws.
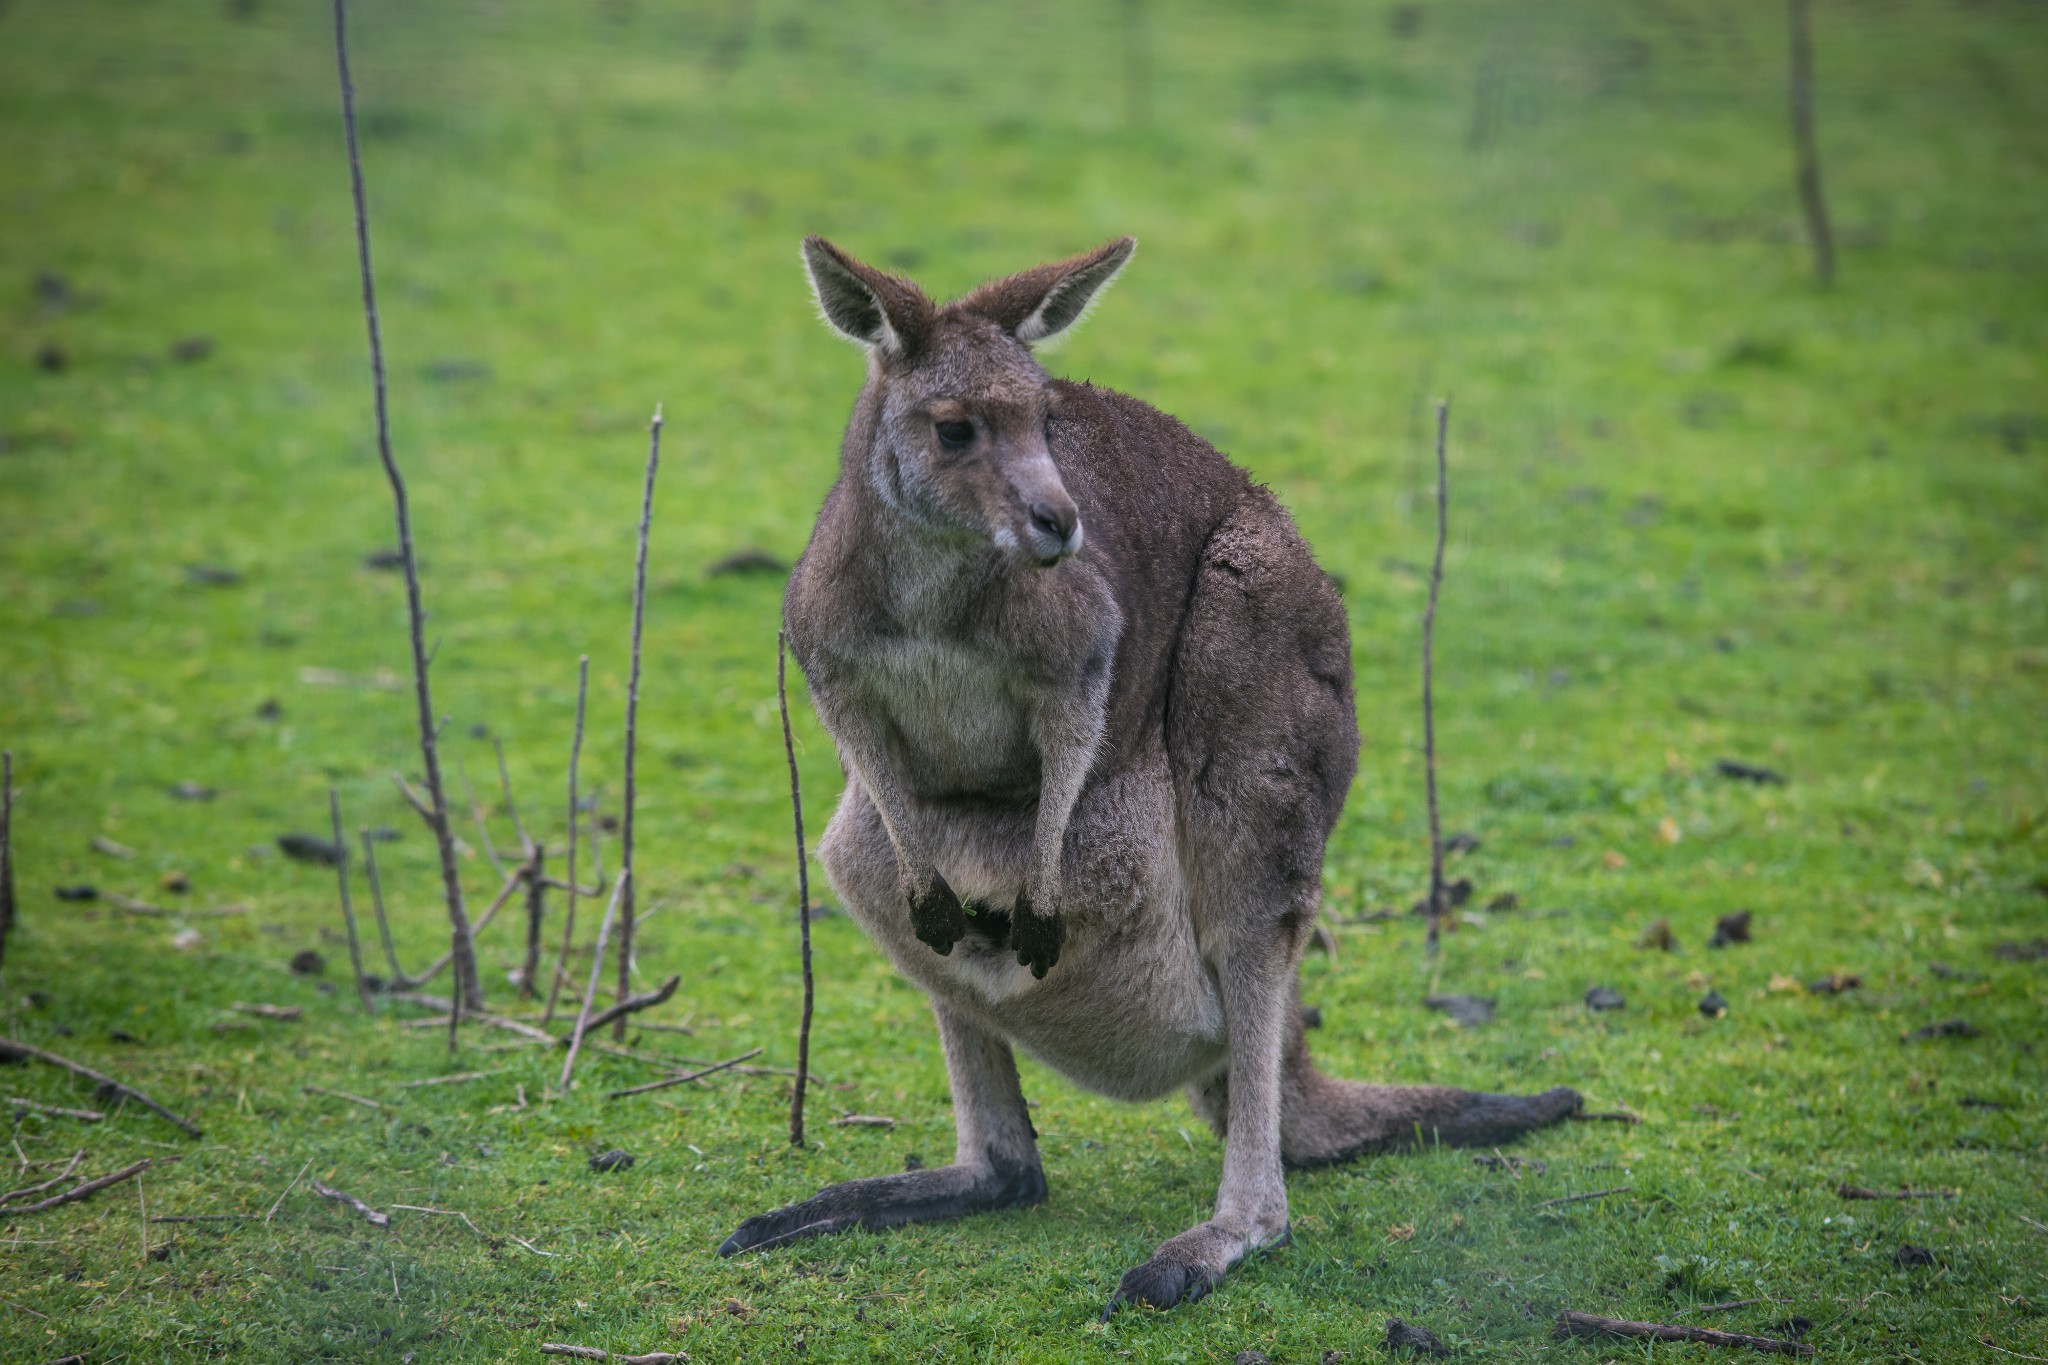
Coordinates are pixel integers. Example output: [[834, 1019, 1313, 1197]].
[[817, 784, 1227, 1099]]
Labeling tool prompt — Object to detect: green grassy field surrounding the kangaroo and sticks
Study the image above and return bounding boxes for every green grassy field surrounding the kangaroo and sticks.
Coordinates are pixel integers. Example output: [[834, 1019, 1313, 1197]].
[[0, 0, 2048, 1365]]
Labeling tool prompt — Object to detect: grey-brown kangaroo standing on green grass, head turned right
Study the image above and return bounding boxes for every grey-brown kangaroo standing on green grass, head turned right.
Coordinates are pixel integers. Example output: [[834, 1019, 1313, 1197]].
[[719, 237, 1579, 1314]]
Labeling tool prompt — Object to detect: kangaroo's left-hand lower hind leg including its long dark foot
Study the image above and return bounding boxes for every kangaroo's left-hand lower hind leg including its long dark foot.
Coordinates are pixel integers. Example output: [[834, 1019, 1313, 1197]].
[[719, 1001, 1044, 1257]]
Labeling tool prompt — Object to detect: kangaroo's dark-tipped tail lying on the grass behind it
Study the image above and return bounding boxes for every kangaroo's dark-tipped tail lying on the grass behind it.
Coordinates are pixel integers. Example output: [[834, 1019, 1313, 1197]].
[[1280, 1072, 1581, 1169]]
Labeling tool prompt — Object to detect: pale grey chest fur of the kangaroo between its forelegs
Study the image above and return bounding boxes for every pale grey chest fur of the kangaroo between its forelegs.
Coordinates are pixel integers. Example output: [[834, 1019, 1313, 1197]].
[[864, 634, 1038, 802]]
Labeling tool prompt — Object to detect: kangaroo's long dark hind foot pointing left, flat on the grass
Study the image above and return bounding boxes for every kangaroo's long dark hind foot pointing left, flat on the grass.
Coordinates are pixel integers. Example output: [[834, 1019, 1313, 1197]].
[[719, 1158, 1044, 1257]]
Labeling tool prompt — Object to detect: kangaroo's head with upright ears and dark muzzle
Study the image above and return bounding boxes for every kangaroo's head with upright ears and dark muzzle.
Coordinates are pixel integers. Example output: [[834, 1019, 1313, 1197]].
[[803, 237, 1137, 567]]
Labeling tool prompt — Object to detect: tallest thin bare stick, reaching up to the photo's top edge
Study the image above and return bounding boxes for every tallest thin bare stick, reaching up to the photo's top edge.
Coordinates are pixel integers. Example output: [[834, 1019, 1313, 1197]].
[[334, 0, 483, 1015]]
